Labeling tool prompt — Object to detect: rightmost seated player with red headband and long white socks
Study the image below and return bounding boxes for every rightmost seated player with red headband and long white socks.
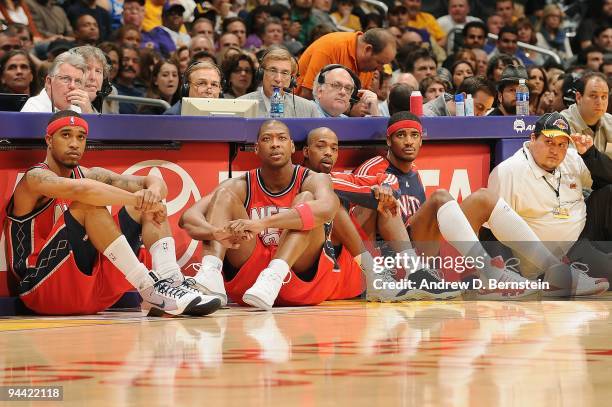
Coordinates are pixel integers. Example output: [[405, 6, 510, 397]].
[[355, 112, 607, 299]]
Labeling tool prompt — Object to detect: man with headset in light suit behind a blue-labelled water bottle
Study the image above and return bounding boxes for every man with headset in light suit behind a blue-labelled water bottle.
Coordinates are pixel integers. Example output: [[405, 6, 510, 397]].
[[238, 47, 319, 117]]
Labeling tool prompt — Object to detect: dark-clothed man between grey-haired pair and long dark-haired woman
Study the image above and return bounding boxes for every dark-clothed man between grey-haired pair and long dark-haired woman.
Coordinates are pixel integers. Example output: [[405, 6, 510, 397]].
[[114, 45, 145, 114]]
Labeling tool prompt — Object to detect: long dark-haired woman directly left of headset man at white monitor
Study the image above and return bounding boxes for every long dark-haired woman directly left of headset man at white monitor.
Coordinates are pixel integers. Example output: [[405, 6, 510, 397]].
[[138, 61, 180, 115]]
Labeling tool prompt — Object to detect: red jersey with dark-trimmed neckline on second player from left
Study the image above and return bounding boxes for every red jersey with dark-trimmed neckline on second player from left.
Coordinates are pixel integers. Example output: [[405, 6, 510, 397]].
[[244, 165, 310, 246]]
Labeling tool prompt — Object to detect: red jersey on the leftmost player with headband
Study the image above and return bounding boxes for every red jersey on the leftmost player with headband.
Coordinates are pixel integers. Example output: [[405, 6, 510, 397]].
[[5, 163, 85, 281]]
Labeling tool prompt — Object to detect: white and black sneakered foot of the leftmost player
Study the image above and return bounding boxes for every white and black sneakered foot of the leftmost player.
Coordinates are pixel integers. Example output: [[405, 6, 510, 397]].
[[139, 273, 221, 316]]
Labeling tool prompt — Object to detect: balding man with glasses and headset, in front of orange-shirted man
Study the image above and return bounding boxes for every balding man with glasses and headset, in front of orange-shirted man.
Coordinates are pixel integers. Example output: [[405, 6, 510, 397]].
[[313, 65, 381, 117]]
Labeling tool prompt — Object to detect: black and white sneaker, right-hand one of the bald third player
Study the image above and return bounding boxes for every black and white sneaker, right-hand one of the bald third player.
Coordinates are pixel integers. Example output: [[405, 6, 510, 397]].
[[397, 267, 463, 300]]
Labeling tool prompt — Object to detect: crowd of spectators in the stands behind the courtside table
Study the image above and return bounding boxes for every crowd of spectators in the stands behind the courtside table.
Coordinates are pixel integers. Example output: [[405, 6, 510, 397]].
[[0, 0, 612, 117]]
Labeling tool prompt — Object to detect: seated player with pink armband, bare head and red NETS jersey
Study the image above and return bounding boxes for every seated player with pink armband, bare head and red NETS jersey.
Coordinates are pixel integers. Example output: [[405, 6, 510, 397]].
[[180, 120, 339, 309]]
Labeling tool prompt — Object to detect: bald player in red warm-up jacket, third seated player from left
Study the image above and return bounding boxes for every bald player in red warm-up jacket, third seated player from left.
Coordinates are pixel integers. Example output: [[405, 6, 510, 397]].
[[303, 127, 461, 302]]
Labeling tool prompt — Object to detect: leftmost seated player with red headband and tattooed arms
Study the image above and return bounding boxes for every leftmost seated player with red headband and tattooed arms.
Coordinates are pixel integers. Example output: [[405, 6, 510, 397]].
[[6, 111, 220, 315]]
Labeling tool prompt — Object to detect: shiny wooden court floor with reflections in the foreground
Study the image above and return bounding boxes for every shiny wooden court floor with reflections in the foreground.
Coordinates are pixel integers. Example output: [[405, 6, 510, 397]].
[[0, 298, 612, 407]]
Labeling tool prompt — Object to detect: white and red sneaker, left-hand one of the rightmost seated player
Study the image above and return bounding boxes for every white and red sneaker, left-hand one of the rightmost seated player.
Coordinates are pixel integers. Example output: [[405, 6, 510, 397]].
[[477, 256, 540, 301]]
